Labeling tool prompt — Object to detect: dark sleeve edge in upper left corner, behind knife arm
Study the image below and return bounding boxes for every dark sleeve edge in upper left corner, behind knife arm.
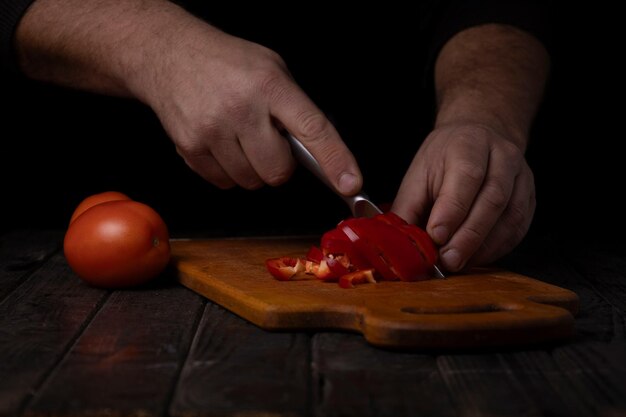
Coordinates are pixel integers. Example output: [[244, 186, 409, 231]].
[[0, 0, 35, 72]]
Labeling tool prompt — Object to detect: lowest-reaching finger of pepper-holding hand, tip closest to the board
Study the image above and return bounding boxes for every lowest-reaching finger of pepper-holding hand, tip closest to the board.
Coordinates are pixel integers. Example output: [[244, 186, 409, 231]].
[[434, 148, 520, 271]]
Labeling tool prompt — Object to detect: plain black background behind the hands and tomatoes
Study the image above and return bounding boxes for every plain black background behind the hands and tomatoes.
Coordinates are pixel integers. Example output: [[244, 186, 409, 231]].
[[0, 4, 626, 239]]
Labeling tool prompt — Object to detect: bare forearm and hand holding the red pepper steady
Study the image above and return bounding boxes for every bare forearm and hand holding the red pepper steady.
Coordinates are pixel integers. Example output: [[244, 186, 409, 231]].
[[392, 25, 549, 271]]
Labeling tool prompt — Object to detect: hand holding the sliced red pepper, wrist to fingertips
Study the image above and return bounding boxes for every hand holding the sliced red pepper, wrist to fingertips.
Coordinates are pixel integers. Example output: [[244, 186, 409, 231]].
[[392, 124, 536, 272]]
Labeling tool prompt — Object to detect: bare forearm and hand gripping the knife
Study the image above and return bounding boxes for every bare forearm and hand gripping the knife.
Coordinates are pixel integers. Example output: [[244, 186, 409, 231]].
[[16, 0, 362, 195]]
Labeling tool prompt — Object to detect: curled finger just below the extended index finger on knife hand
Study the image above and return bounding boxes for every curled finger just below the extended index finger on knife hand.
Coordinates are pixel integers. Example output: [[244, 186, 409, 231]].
[[239, 114, 295, 186]]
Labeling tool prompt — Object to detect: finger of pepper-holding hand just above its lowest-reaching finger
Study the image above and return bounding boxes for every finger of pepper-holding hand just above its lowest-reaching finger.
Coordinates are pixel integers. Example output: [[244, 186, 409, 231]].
[[426, 145, 489, 245]]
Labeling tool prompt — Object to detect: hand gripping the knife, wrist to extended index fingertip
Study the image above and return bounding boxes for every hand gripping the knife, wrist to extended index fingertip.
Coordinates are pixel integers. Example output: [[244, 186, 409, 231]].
[[136, 22, 362, 195]]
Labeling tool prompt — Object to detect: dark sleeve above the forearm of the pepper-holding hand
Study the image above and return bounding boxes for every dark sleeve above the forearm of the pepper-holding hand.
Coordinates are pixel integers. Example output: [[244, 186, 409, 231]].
[[420, 0, 554, 81]]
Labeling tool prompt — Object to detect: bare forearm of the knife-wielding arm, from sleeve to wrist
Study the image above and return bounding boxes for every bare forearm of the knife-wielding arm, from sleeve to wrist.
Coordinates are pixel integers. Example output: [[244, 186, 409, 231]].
[[15, 0, 206, 99]]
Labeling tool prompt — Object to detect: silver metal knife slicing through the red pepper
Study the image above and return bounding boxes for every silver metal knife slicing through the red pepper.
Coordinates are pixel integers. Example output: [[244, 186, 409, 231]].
[[284, 131, 445, 278]]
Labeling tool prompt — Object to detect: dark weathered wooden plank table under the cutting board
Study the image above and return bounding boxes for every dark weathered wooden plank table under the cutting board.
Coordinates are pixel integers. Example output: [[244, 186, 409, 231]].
[[0, 230, 626, 417]]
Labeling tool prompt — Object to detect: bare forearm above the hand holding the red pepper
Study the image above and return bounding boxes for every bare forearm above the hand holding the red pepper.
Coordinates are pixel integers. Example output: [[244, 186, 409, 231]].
[[435, 24, 549, 151]]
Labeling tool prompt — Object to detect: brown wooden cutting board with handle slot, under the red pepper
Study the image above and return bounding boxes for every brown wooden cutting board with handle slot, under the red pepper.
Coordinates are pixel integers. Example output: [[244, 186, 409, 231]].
[[172, 238, 578, 348]]
